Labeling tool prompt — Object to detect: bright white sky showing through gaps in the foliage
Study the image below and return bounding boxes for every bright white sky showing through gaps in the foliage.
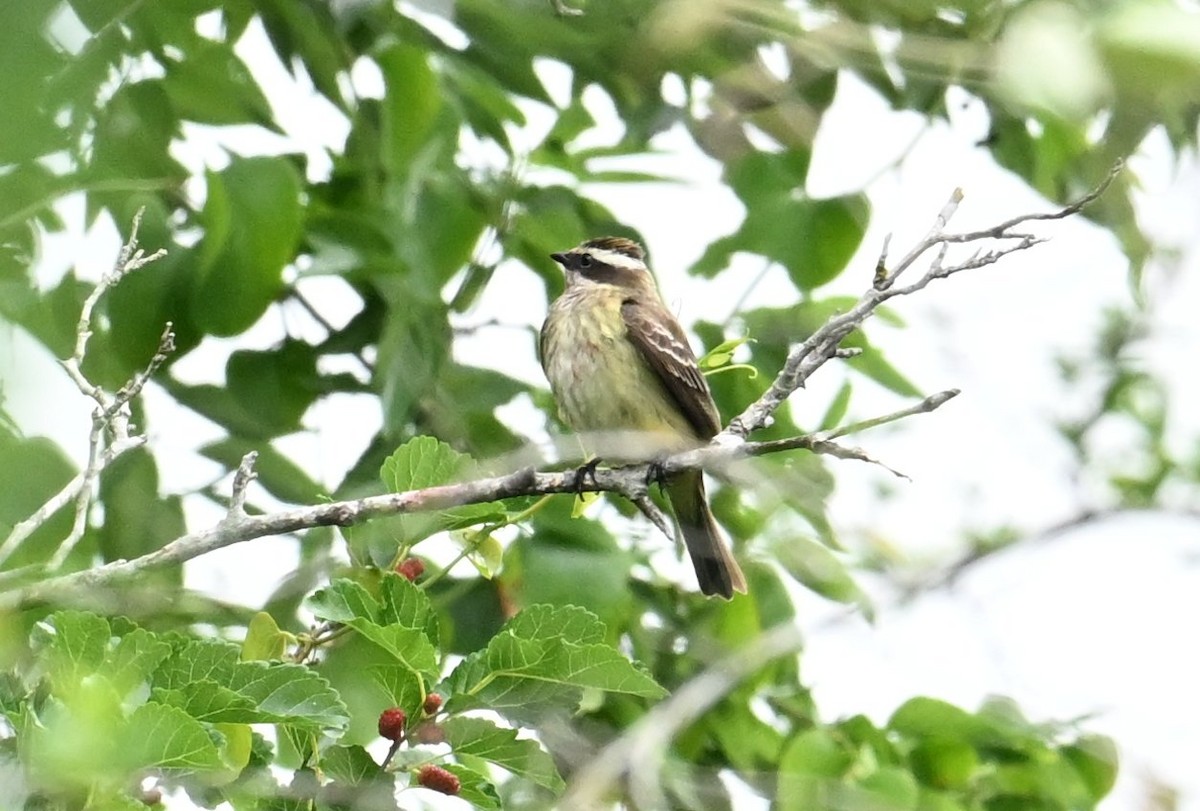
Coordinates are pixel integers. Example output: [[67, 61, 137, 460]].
[[0, 7, 1200, 811]]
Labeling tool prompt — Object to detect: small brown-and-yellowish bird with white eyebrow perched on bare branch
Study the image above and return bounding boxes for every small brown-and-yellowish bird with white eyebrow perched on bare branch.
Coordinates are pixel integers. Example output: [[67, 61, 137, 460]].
[[540, 236, 746, 599]]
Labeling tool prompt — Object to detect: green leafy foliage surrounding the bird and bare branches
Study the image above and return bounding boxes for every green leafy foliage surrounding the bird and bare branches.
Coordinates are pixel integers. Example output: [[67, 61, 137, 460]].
[[0, 0, 1200, 811]]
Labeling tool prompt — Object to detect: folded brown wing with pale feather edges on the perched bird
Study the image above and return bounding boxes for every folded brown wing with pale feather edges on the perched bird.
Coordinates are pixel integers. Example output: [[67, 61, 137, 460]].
[[620, 299, 721, 439]]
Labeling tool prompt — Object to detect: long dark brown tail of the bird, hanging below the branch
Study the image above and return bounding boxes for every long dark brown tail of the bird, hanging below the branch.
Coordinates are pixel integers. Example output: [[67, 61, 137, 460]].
[[667, 470, 746, 600]]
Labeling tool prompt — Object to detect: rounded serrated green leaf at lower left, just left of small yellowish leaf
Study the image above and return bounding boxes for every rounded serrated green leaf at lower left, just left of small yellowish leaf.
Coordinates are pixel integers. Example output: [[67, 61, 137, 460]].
[[115, 702, 223, 770]]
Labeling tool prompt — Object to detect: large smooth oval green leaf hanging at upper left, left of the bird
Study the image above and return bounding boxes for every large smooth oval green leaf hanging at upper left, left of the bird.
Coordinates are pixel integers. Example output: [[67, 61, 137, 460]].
[[191, 157, 302, 336]]
